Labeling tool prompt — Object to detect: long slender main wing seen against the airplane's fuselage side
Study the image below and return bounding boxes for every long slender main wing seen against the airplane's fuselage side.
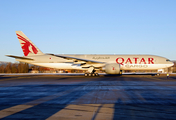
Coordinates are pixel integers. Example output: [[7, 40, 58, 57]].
[[49, 54, 104, 64]]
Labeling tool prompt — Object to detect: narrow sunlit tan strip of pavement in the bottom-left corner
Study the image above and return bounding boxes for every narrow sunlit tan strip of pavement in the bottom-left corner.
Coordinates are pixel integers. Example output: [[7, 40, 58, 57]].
[[0, 105, 33, 119]]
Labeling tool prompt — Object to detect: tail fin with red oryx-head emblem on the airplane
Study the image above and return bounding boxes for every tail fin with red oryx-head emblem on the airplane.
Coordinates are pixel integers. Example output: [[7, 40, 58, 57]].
[[16, 31, 43, 56]]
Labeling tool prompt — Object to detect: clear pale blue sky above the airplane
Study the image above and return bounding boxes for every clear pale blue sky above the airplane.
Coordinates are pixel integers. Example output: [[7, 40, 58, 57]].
[[0, 0, 176, 62]]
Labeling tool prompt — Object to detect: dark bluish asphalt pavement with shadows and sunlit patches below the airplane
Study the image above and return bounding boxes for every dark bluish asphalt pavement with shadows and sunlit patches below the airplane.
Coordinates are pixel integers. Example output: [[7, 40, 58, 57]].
[[0, 75, 176, 120]]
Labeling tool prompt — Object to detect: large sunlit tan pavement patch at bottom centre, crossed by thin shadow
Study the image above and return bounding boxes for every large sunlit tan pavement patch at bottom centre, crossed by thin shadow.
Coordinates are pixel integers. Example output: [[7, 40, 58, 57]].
[[46, 104, 114, 120]]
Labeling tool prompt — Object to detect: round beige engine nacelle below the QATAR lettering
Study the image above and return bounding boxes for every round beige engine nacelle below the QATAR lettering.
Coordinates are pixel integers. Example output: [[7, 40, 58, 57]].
[[105, 63, 120, 74]]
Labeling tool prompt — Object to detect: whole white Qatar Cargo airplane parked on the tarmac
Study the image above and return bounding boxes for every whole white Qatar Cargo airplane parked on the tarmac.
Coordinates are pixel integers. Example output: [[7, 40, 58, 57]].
[[6, 31, 174, 76]]
